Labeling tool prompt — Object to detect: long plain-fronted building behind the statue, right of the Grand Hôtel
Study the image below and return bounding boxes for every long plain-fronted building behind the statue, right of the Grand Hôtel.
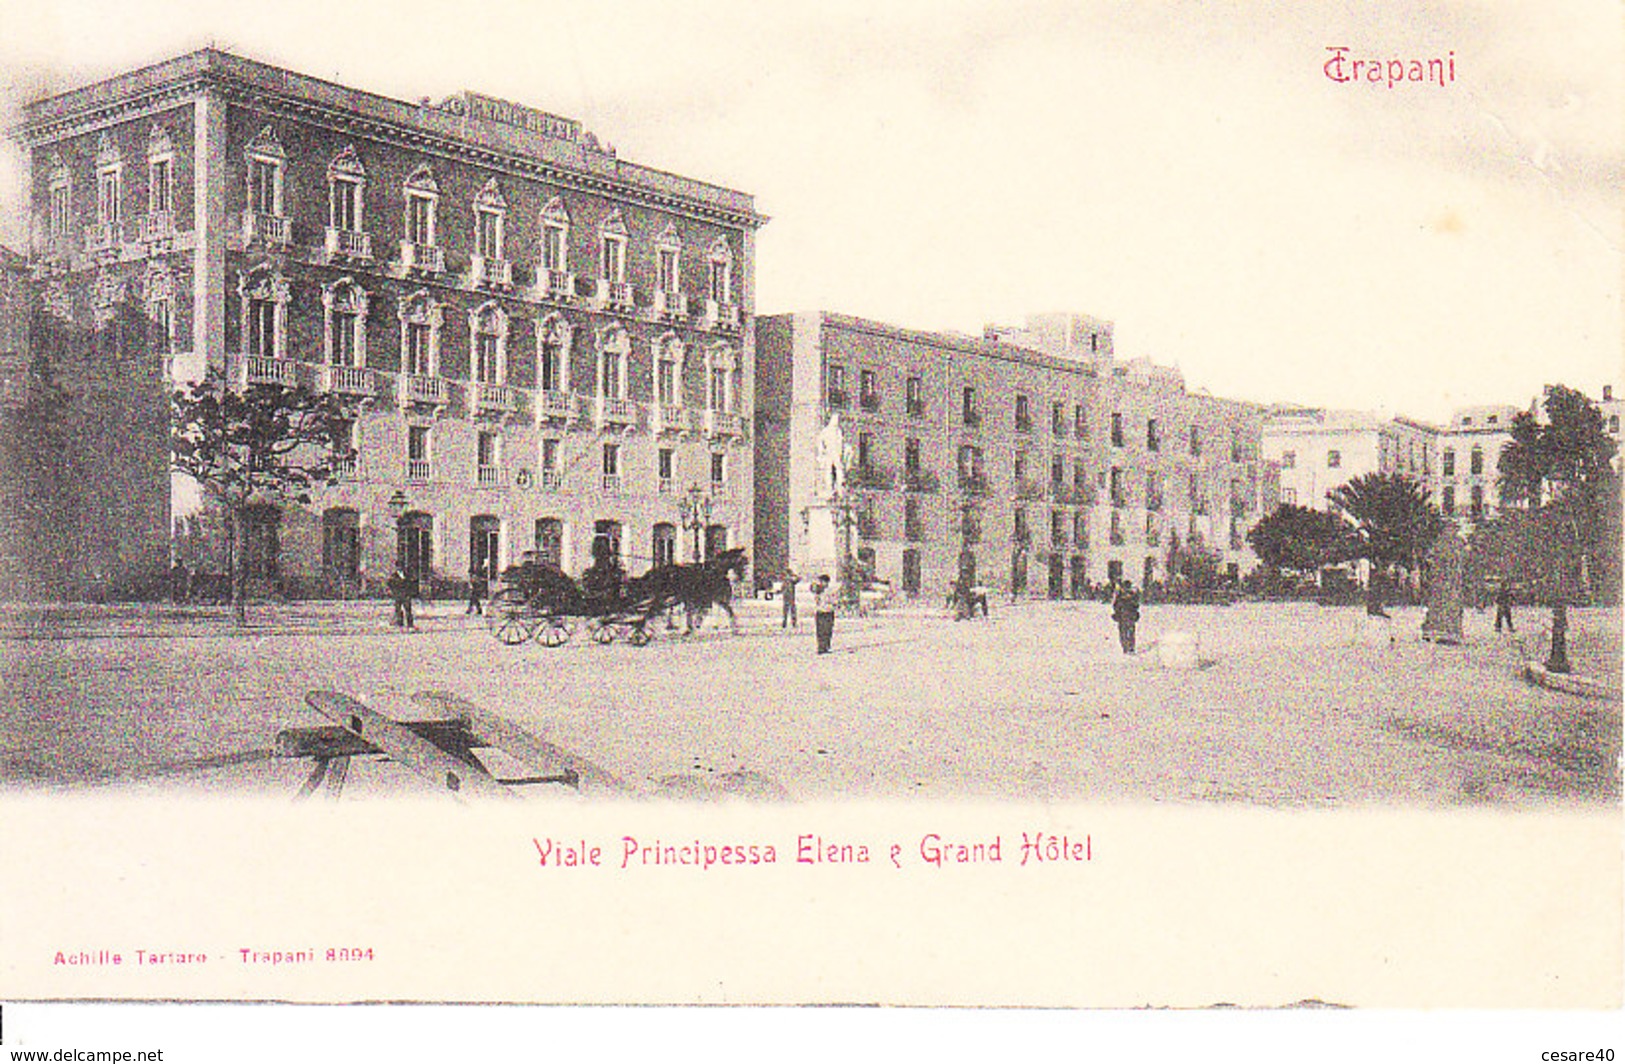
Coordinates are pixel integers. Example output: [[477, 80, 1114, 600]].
[[756, 314, 1276, 598]]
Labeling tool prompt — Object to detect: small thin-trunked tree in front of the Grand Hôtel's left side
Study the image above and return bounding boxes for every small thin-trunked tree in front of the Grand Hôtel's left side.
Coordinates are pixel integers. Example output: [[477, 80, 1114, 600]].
[[171, 365, 356, 624]]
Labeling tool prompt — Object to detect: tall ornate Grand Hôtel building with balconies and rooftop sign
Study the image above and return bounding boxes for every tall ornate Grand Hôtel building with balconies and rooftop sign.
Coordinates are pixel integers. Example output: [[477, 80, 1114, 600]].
[[23, 50, 765, 590]]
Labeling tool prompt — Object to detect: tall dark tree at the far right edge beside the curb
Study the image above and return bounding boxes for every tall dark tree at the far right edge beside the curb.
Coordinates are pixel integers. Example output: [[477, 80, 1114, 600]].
[[1498, 385, 1620, 673]]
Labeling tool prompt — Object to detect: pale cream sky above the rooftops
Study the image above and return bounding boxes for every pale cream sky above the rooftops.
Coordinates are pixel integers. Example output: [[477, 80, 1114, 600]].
[[0, 0, 1625, 421]]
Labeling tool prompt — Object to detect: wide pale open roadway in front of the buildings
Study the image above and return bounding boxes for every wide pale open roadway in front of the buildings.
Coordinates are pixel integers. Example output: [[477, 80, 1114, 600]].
[[0, 603, 1620, 806]]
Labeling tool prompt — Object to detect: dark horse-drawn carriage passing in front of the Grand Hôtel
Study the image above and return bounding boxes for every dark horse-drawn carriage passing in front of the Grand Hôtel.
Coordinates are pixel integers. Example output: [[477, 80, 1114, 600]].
[[486, 547, 746, 647]]
